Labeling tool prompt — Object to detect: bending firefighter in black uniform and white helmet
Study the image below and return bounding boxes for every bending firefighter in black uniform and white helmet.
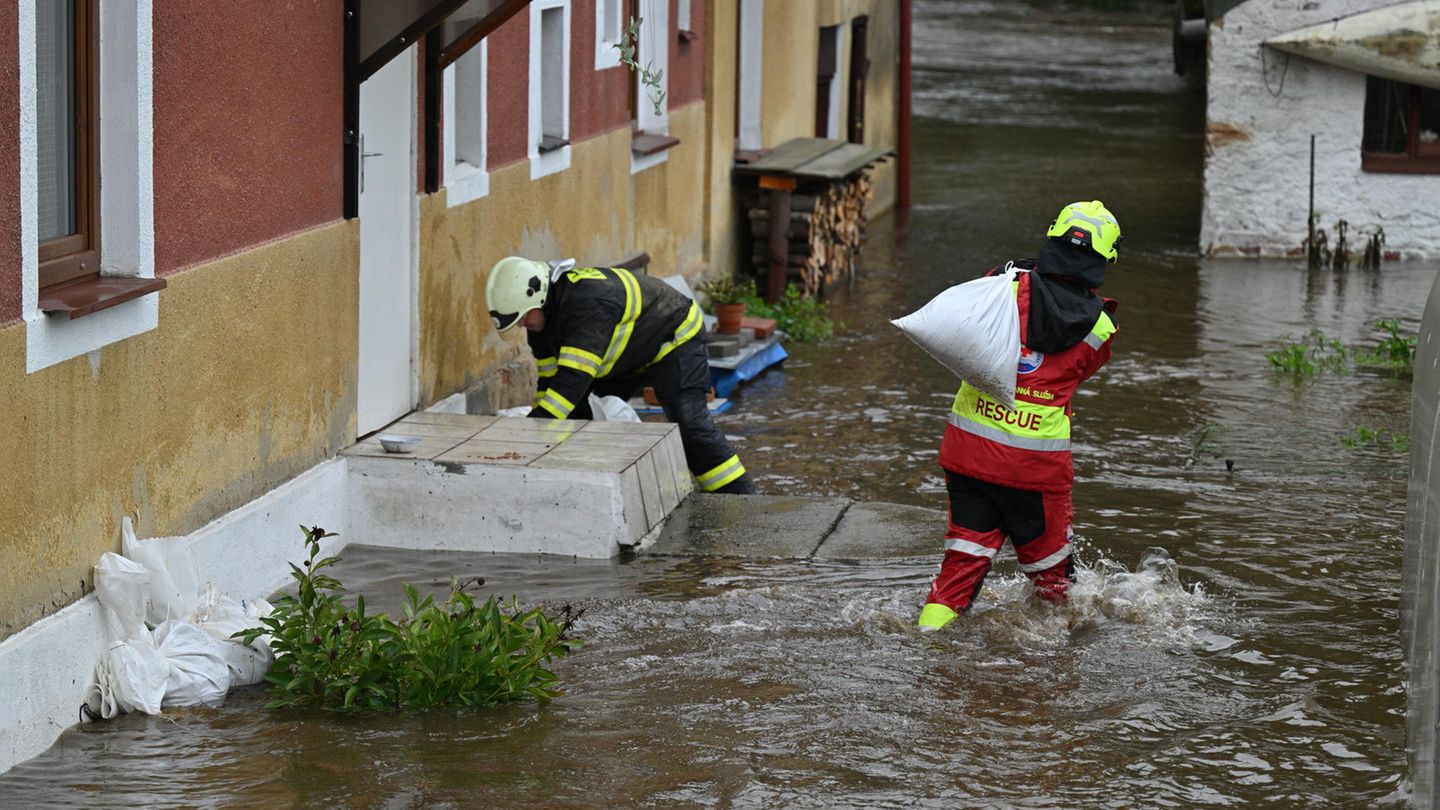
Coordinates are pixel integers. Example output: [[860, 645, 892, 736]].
[[485, 257, 755, 494]]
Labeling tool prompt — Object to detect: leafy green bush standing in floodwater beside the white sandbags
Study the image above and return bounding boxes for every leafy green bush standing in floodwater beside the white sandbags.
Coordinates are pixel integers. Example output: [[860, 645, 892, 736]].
[[236, 526, 580, 711]]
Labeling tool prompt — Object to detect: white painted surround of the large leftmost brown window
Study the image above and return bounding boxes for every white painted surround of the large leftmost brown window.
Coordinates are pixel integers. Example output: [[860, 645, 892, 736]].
[[17, 0, 160, 373]]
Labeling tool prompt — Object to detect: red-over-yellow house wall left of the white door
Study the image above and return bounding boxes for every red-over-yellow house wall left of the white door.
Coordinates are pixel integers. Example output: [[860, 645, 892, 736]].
[[0, 0, 359, 638]]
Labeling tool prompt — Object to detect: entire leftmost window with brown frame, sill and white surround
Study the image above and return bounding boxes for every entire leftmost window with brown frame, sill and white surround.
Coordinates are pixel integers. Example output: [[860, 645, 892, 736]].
[[17, 0, 166, 372]]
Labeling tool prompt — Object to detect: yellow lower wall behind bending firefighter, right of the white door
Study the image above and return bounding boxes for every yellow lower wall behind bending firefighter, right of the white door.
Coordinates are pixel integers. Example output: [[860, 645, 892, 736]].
[[419, 102, 707, 408]]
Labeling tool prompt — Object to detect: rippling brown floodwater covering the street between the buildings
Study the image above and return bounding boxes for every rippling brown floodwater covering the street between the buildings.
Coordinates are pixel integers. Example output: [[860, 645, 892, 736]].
[[0, 0, 1440, 807]]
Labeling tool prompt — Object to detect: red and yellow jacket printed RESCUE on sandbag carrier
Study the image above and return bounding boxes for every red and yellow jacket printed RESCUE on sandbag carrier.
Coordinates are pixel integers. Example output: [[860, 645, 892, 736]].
[[940, 271, 1116, 491]]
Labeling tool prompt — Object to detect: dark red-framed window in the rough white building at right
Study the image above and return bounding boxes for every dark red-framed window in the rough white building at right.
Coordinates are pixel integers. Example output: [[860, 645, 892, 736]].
[[1361, 76, 1440, 174]]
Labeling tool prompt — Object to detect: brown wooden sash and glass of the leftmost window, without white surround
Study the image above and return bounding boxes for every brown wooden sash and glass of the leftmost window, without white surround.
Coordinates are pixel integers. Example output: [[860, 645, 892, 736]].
[[35, 0, 99, 287]]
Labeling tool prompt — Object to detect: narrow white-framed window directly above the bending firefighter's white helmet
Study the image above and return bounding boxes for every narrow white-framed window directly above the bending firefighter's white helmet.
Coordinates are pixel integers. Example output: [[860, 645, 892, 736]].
[[530, 0, 570, 180]]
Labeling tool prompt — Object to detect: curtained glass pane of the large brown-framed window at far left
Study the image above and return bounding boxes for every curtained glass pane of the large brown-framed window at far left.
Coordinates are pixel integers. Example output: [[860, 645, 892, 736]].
[[35, 0, 75, 242]]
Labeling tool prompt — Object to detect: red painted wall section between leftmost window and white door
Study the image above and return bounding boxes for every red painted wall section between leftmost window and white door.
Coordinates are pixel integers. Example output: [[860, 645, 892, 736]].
[[154, 0, 344, 275]]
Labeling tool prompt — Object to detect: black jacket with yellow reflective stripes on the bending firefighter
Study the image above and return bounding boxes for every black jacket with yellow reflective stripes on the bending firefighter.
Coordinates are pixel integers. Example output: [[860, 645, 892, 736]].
[[528, 267, 704, 419]]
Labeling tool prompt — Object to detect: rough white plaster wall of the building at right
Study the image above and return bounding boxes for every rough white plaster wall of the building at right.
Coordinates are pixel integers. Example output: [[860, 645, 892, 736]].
[[1200, 0, 1440, 257]]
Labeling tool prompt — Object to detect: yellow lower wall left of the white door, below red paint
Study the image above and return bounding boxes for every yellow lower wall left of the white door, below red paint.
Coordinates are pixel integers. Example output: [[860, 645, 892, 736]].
[[0, 222, 359, 637]]
